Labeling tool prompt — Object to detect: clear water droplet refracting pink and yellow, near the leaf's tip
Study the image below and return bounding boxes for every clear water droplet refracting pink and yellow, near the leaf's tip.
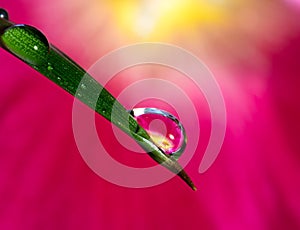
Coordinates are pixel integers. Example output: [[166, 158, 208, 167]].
[[130, 108, 187, 159]]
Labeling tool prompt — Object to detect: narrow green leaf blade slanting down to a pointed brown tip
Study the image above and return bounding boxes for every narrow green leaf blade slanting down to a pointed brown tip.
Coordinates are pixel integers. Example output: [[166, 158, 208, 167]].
[[0, 14, 196, 190]]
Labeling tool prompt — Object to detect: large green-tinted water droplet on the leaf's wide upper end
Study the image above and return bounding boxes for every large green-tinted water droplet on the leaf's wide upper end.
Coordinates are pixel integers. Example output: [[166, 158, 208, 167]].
[[1, 24, 50, 65]]
